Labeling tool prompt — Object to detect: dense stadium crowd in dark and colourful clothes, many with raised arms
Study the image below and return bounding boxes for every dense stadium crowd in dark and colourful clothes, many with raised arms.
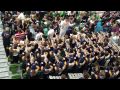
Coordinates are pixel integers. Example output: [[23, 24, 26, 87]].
[[1, 11, 120, 79]]
